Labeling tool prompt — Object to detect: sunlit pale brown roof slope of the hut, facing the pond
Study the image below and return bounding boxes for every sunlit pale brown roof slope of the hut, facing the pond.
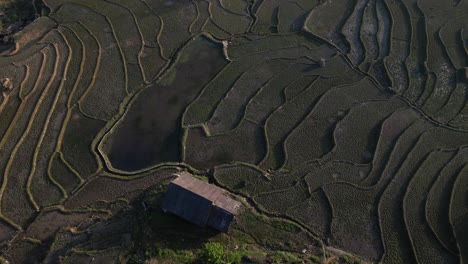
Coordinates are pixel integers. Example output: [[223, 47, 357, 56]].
[[172, 172, 241, 214]]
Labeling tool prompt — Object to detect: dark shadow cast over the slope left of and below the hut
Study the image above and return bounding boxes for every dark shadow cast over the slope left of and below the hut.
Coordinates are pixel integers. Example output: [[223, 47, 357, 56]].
[[38, 185, 219, 263]]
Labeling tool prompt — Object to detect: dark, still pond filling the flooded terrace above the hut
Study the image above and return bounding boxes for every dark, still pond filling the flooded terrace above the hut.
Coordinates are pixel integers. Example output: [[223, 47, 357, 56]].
[[105, 37, 227, 171]]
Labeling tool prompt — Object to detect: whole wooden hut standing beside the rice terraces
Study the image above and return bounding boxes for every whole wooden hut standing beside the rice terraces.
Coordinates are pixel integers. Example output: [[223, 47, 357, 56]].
[[162, 172, 241, 232]]
